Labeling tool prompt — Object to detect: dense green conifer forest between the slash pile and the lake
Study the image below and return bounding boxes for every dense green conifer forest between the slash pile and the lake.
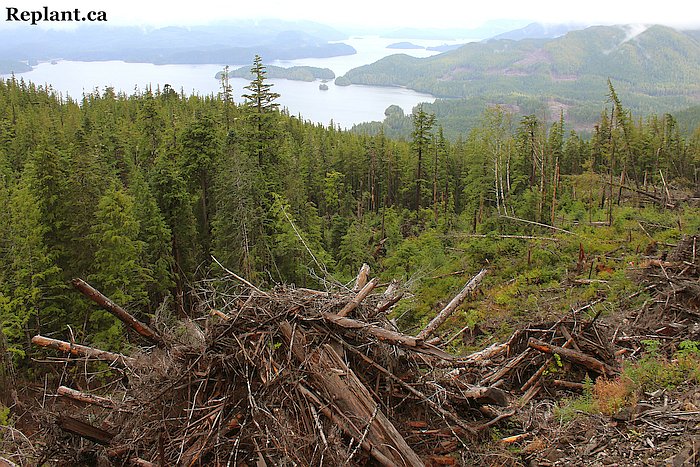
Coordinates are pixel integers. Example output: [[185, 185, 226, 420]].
[[0, 61, 700, 359]]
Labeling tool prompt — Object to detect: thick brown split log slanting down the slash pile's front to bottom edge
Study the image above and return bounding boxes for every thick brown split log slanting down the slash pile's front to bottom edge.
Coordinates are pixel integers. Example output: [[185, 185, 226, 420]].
[[280, 322, 423, 467]]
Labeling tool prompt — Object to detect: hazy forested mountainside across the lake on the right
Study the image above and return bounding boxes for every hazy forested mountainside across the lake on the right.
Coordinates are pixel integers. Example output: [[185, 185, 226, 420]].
[[338, 26, 700, 135]]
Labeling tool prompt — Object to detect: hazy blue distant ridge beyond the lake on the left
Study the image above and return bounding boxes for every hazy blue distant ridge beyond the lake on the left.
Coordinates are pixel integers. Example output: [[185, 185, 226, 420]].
[[0, 20, 356, 72]]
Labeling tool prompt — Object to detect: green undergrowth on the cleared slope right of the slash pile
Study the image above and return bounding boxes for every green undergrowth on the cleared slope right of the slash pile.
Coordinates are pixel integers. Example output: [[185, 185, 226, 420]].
[[382, 201, 700, 353]]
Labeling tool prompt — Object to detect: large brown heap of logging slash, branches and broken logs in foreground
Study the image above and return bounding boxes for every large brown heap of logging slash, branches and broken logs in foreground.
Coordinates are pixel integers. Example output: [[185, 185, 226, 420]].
[[5, 237, 700, 466]]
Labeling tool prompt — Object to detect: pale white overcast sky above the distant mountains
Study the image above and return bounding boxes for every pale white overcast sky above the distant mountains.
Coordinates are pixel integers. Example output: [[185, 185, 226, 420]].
[[9, 0, 700, 28]]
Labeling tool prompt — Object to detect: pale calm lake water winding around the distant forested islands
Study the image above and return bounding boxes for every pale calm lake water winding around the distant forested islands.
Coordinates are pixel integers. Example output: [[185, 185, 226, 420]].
[[5, 37, 470, 128]]
